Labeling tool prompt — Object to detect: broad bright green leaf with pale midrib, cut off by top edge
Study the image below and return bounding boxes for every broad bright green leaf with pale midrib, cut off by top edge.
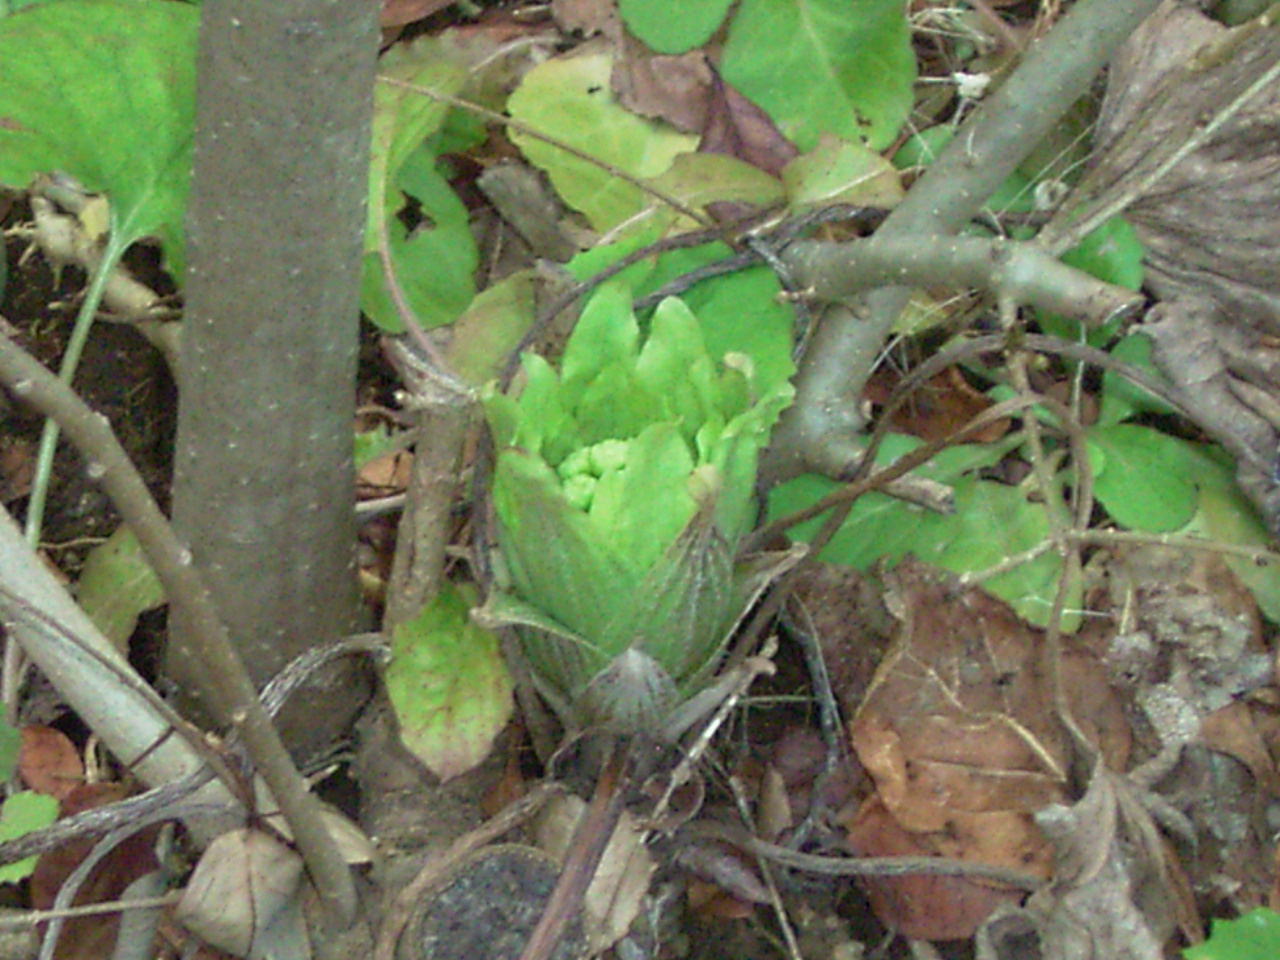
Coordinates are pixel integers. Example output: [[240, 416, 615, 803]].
[[721, 0, 915, 152]]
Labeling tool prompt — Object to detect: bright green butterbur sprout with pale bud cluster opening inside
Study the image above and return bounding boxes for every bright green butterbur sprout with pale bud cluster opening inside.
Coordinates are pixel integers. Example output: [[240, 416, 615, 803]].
[[480, 284, 794, 737]]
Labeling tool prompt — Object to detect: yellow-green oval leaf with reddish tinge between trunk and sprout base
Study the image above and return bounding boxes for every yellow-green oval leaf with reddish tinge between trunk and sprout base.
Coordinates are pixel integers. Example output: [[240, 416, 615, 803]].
[[387, 582, 513, 781]]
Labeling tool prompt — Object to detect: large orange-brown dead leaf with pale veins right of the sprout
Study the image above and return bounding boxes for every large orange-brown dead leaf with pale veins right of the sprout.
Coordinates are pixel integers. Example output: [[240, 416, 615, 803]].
[[847, 561, 1129, 940]]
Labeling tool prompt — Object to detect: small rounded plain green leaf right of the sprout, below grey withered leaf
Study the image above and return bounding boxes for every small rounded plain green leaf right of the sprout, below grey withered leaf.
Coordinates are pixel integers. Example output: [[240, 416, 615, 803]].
[[1088, 424, 1198, 534]]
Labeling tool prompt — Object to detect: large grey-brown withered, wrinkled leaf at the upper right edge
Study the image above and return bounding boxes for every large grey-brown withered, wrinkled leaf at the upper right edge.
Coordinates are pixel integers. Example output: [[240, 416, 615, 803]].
[[1062, 0, 1280, 529]]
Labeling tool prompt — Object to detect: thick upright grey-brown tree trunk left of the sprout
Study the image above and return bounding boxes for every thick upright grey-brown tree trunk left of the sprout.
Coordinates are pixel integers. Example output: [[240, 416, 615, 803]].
[[169, 0, 378, 746]]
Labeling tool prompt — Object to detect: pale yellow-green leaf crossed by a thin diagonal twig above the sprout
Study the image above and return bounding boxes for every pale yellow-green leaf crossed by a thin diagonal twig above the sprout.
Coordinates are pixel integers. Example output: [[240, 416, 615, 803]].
[[507, 52, 698, 233]]
